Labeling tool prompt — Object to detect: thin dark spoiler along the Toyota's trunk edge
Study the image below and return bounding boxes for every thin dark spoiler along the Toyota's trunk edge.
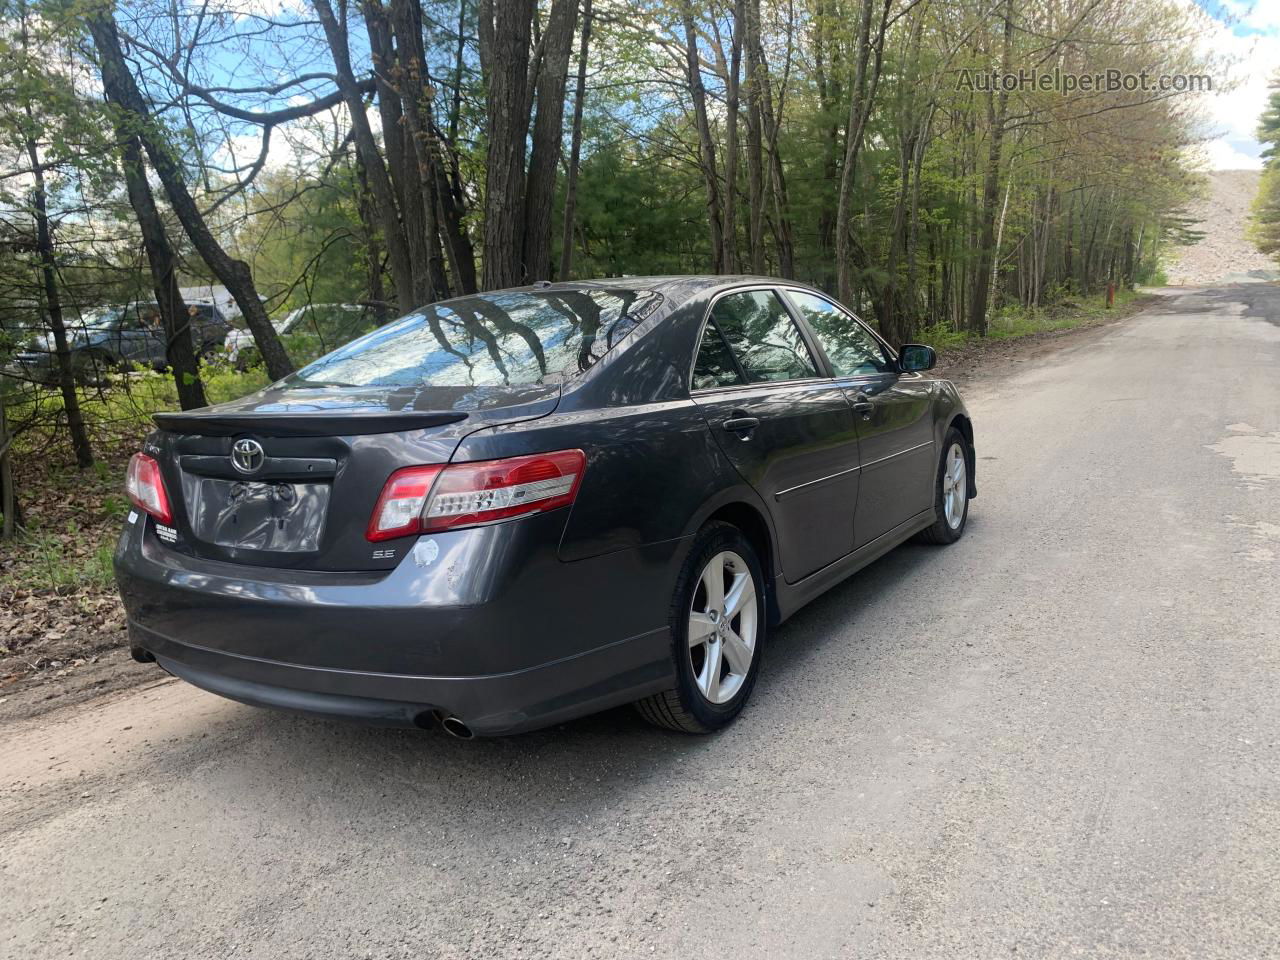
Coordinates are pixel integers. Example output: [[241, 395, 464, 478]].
[[151, 410, 467, 436]]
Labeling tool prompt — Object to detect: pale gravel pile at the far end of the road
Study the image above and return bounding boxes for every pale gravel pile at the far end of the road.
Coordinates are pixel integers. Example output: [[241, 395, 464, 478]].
[[1167, 170, 1280, 285]]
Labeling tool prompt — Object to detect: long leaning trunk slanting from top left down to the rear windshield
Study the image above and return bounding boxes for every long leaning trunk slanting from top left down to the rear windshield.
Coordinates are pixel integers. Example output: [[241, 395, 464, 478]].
[[88, 11, 293, 379]]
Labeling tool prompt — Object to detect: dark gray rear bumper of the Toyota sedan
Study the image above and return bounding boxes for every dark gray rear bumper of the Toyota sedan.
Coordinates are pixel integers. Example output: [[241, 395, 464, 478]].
[[115, 517, 682, 736]]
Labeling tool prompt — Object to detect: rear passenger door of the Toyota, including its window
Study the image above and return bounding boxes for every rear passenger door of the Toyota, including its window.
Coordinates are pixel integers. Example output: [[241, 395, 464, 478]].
[[691, 288, 858, 582]]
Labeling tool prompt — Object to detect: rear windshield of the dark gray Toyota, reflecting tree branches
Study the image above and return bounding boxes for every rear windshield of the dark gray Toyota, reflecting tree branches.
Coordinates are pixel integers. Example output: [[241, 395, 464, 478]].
[[289, 289, 662, 387]]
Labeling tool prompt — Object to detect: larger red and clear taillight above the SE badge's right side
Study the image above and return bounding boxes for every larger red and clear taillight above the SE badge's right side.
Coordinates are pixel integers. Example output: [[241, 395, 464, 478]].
[[366, 451, 586, 540]]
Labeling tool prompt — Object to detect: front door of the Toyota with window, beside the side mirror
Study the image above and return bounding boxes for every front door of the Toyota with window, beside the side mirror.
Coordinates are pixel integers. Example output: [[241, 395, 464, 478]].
[[786, 289, 937, 547]]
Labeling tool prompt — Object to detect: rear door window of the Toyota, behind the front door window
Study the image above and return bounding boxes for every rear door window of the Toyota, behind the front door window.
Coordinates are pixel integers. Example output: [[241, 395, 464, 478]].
[[712, 291, 818, 383]]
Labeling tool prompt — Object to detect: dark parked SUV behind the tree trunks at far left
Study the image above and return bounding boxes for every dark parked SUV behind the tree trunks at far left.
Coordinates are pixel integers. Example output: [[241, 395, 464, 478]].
[[14, 301, 230, 383]]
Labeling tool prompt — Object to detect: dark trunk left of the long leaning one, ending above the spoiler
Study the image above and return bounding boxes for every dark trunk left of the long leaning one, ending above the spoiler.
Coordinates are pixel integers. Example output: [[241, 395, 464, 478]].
[[115, 131, 209, 410]]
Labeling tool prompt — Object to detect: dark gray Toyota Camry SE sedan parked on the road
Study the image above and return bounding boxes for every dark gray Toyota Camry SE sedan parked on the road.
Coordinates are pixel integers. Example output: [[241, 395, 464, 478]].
[[115, 276, 977, 737]]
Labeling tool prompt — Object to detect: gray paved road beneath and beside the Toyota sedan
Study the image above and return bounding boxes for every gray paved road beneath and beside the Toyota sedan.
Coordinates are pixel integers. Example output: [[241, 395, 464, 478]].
[[0, 287, 1280, 960]]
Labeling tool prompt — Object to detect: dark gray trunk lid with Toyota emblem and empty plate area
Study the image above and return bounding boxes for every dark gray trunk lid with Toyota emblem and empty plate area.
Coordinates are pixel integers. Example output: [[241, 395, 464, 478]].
[[147, 384, 559, 570]]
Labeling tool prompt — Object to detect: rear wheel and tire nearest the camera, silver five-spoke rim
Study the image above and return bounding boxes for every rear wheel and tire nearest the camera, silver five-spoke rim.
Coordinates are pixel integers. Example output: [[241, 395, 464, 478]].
[[635, 522, 768, 733]]
